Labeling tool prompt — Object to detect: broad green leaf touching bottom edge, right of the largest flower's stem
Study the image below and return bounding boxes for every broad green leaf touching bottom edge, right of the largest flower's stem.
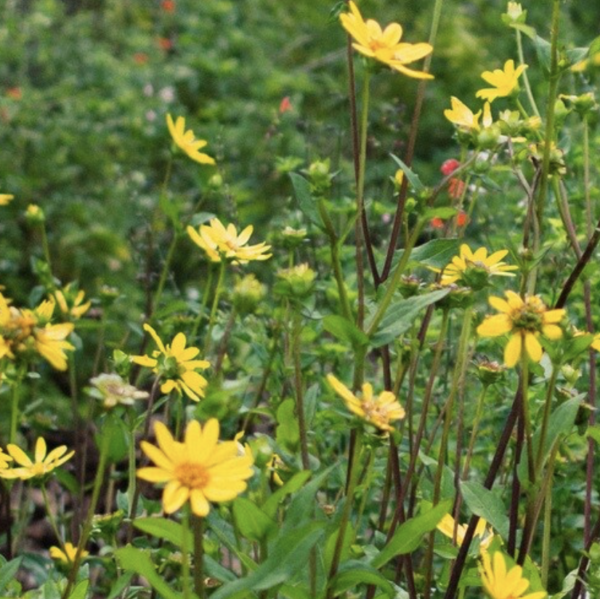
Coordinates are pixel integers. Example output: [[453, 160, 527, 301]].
[[211, 522, 325, 599]]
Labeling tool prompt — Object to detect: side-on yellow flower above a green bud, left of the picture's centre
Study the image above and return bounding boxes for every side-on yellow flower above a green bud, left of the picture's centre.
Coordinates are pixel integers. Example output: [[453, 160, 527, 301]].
[[187, 218, 272, 264]]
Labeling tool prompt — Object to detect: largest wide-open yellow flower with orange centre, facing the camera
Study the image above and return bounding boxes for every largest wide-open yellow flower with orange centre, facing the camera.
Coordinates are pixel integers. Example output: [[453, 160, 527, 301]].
[[137, 418, 254, 517]]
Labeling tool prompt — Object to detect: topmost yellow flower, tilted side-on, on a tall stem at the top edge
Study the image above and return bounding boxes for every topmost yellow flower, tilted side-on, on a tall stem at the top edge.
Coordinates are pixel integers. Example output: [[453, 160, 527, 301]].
[[340, 0, 433, 79]]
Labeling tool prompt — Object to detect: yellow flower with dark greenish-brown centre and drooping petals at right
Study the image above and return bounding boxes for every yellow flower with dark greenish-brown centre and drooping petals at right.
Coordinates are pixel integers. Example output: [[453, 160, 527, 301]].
[[477, 291, 566, 368]]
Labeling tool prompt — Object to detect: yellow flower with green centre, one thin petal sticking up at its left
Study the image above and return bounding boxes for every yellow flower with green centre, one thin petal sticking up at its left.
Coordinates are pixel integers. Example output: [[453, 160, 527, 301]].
[[131, 324, 210, 401]]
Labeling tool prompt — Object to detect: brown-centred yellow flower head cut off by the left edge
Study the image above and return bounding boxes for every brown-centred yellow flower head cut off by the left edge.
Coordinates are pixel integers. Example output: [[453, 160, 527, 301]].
[[0, 293, 75, 370]]
